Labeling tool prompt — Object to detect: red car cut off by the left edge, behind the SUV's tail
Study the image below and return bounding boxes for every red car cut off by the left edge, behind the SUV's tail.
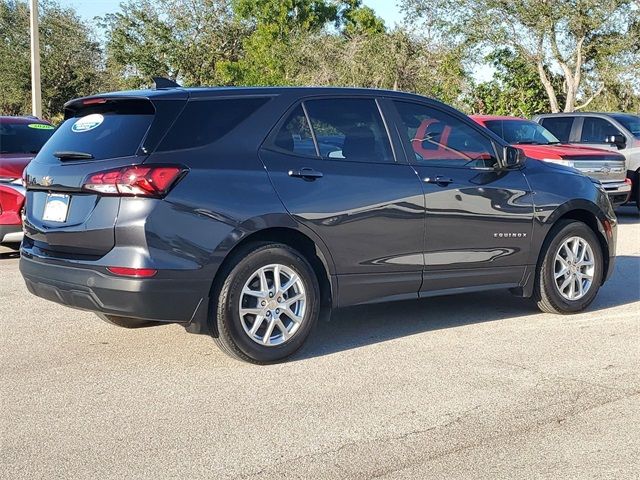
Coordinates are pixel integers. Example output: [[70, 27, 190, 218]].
[[0, 116, 54, 247]]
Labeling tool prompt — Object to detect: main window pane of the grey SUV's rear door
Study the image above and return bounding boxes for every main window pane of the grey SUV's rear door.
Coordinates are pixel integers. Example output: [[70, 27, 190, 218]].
[[304, 98, 394, 163]]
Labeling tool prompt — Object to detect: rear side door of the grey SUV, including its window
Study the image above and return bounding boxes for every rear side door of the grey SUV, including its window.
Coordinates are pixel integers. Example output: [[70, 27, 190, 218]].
[[260, 98, 425, 304]]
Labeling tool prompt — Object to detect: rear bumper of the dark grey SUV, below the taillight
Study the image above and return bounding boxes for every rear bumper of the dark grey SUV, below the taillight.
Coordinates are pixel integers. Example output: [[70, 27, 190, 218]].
[[20, 248, 211, 326]]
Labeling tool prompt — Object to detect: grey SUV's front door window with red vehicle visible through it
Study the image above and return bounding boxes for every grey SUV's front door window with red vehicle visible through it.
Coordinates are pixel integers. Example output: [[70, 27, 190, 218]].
[[394, 101, 497, 167]]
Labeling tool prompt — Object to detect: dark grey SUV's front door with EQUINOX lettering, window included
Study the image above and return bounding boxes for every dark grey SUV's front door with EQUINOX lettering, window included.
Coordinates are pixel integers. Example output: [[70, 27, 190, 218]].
[[393, 101, 533, 292]]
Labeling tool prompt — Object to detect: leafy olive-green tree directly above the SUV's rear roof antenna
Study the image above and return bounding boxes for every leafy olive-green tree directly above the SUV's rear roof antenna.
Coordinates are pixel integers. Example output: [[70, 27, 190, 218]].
[[102, 0, 249, 88]]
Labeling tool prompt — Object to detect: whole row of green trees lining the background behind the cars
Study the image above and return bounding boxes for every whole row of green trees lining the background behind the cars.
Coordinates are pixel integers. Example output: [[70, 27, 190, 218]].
[[0, 0, 640, 117]]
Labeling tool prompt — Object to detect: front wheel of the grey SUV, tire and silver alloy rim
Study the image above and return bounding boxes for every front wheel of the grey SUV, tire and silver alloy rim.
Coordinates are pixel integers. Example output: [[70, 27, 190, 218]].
[[534, 220, 604, 314]]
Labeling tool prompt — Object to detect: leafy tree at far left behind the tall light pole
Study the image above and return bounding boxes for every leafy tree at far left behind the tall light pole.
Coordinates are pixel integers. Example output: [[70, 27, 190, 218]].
[[0, 0, 104, 118]]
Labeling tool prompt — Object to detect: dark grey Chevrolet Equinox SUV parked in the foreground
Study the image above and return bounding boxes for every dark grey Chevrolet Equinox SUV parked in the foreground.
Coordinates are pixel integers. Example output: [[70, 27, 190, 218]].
[[20, 87, 616, 363]]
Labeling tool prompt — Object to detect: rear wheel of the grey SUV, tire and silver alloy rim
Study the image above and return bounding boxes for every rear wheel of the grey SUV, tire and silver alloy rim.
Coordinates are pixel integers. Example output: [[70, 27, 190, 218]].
[[211, 243, 320, 364]]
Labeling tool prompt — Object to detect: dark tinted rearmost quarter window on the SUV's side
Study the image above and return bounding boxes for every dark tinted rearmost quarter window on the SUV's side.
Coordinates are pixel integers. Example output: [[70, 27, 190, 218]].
[[158, 97, 269, 151]]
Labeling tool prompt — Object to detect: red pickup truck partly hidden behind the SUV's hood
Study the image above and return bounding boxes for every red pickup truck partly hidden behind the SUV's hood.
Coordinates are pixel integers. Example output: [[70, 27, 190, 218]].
[[471, 115, 631, 207]]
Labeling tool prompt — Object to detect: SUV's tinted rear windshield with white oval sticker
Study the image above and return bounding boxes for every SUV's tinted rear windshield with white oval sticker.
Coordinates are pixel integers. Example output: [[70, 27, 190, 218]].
[[42, 100, 154, 160]]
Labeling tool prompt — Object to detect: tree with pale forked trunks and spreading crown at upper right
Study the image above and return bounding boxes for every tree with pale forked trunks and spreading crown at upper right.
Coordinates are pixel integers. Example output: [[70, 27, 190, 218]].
[[402, 0, 640, 112]]
